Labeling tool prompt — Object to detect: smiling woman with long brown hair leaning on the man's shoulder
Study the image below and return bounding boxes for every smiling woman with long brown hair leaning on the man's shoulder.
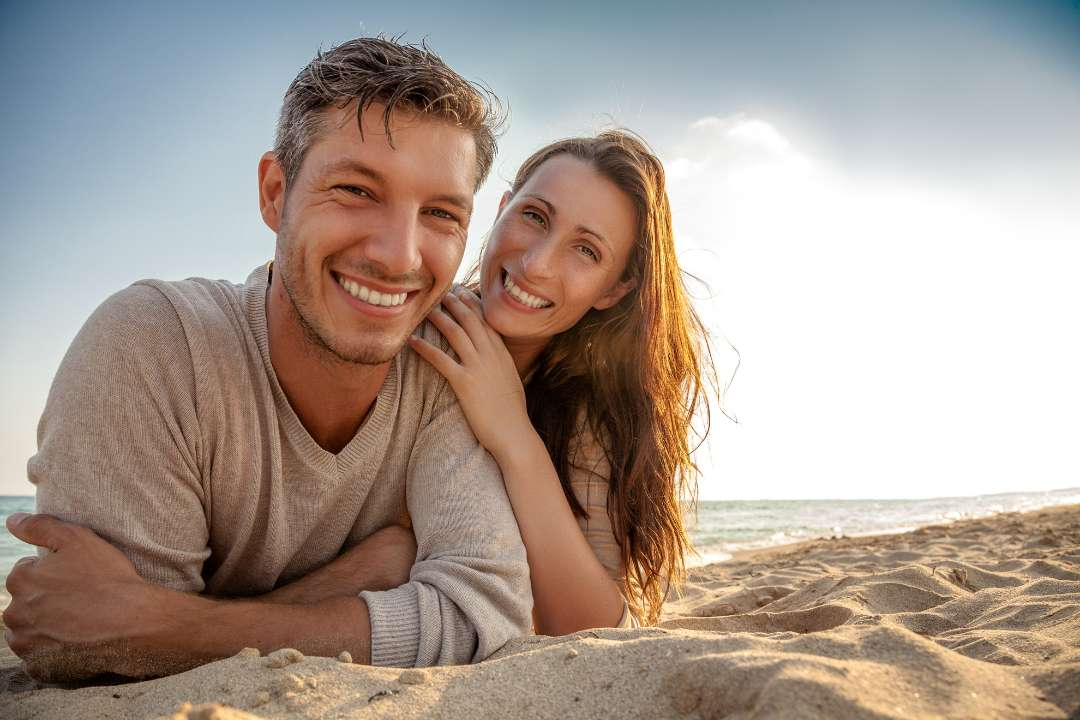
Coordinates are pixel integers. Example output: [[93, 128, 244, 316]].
[[410, 131, 711, 635]]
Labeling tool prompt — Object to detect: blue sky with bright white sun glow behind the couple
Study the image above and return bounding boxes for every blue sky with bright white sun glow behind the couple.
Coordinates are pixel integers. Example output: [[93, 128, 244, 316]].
[[0, 0, 1080, 500]]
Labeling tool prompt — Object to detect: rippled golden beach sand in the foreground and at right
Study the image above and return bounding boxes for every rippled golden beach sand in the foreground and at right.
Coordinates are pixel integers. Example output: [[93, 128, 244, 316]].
[[0, 505, 1080, 720]]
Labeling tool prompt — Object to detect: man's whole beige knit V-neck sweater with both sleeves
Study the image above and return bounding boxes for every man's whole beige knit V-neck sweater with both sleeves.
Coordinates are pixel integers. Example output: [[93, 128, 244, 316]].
[[28, 268, 532, 666]]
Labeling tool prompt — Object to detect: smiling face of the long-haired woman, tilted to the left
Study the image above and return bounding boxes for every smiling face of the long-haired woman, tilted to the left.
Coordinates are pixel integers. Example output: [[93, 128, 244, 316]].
[[481, 154, 636, 340]]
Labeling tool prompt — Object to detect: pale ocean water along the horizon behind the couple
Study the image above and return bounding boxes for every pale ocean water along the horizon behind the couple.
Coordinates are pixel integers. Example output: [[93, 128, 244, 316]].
[[0, 488, 1080, 607]]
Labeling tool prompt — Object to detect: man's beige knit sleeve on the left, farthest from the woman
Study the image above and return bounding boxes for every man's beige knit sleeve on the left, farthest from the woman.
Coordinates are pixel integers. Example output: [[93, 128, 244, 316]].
[[27, 285, 210, 592]]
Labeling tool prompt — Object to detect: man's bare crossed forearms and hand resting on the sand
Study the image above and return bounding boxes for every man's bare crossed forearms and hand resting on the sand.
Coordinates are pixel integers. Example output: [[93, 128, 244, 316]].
[[3, 513, 416, 682]]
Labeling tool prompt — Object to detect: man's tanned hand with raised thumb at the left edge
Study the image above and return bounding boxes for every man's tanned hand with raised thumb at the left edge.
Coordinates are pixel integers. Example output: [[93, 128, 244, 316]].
[[3, 513, 173, 682]]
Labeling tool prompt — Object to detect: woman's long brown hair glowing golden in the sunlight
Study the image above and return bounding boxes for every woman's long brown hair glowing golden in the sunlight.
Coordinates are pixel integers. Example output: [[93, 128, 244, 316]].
[[492, 130, 714, 624]]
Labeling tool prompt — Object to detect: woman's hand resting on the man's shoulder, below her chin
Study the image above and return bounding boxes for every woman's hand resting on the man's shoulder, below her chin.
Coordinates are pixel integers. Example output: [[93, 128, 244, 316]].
[[409, 289, 536, 461]]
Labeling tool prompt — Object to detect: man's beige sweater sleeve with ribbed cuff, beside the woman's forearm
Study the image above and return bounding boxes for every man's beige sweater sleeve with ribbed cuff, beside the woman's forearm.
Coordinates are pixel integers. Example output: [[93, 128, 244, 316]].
[[362, 343, 532, 666]]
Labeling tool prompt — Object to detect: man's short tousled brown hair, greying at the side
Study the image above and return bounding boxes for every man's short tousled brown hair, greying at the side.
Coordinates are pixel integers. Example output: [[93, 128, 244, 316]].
[[274, 37, 504, 189]]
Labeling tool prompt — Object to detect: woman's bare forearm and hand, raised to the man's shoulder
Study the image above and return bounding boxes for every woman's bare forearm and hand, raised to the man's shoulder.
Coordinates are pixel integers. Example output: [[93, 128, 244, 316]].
[[410, 294, 626, 635]]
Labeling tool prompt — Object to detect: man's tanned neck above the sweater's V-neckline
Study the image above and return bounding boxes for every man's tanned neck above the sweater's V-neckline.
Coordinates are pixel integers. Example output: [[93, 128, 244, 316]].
[[267, 276, 390, 454]]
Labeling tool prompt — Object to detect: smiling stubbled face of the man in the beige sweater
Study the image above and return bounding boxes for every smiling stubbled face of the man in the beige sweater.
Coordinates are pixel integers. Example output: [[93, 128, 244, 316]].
[[265, 105, 476, 365]]
